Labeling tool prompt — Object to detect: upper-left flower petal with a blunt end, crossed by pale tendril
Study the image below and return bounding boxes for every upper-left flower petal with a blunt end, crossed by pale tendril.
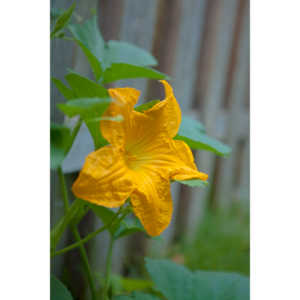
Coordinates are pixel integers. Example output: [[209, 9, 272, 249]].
[[100, 88, 140, 146]]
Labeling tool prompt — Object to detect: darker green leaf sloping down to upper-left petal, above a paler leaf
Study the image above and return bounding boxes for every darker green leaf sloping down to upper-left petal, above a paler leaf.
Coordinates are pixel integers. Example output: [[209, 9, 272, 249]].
[[66, 72, 109, 98]]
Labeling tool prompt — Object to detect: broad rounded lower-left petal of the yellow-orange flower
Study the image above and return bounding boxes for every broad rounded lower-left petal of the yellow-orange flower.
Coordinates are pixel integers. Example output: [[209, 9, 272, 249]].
[[72, 145, 133, 207]]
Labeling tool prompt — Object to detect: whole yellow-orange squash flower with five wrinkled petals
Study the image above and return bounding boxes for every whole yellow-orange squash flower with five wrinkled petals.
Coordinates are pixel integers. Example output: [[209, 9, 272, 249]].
[[72, 81, 208, 236]]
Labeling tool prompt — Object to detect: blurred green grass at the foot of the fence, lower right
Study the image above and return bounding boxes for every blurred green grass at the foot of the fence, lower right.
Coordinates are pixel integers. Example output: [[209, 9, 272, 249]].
[[182, 205, 250, 275]]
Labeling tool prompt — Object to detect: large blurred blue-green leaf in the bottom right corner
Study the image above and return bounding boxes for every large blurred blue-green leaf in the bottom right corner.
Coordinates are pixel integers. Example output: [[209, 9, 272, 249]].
[[146, 258, 249, 300]]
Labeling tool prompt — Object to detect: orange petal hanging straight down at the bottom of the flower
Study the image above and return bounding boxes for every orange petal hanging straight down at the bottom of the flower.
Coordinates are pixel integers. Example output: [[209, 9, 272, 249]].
[[130, 170, 173, 236]]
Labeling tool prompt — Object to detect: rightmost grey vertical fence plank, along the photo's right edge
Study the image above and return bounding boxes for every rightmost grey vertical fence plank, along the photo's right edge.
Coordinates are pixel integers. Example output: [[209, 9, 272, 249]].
[[216, 3, 249, 208]]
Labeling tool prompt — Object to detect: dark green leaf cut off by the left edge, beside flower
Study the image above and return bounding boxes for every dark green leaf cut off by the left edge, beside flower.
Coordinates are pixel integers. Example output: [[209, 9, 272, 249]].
[[50, 123, 71, 170]]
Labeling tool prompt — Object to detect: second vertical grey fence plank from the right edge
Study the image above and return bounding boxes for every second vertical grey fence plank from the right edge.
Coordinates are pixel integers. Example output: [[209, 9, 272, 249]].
[[188, 0, 239, 236]]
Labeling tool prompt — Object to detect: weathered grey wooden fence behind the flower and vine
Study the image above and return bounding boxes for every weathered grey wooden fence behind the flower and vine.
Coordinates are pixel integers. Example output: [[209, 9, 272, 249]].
[[51, 0, 249, 296]]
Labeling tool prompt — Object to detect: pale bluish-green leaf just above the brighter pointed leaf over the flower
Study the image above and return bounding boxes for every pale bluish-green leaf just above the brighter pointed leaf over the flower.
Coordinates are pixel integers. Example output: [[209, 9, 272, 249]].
[[104, 41, 157, 66]]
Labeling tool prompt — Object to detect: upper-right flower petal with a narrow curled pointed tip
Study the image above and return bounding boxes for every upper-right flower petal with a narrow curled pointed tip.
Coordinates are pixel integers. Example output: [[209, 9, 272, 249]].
[[144, 80, 181, 138]]
